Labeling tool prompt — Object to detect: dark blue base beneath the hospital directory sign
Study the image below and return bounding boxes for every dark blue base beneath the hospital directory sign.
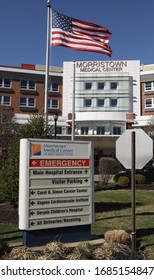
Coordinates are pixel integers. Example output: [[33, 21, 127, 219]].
[[23, 225, 91, 247]]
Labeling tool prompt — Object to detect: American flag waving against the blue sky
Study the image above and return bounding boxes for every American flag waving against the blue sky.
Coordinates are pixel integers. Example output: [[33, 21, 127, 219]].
[[51, 10, 112, 56]]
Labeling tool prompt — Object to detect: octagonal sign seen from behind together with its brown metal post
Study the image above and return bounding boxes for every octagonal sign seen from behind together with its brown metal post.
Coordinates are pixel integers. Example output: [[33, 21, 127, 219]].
[[116, 129, 153, 250]]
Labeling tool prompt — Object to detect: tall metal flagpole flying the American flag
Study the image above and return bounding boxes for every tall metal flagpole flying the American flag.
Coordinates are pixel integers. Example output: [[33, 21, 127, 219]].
[[44, 0, 51, 128]]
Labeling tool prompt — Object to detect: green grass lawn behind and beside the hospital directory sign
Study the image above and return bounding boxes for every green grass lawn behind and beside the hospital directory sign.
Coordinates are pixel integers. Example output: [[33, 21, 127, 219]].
[[0, 189, 154, 260]]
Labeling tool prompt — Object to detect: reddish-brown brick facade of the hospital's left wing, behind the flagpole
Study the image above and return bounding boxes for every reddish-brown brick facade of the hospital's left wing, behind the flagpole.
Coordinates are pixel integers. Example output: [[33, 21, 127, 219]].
[[0, 64, 63, 118]]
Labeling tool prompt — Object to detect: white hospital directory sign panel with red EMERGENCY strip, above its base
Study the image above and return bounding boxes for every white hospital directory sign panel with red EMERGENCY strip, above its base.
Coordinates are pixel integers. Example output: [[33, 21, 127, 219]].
[[19, 139, 94, 230]]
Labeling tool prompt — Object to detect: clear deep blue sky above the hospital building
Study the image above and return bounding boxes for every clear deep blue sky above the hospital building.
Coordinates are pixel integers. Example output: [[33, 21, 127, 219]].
[[0, 0, 154, 66]]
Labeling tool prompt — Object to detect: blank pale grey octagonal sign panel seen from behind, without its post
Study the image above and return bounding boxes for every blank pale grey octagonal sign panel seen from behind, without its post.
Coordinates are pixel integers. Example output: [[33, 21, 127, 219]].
[[116, 129, 153, 169]]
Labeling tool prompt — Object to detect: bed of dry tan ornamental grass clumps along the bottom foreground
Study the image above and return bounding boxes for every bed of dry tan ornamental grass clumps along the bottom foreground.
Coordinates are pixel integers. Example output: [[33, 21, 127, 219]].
[[0, 230, 147, 260]]
